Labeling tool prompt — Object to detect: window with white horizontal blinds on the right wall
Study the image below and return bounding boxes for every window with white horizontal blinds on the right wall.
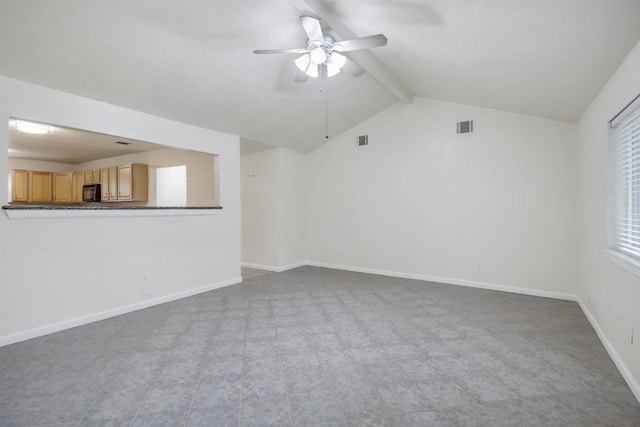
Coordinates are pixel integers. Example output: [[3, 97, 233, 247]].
[[610, 96, 640, 265]]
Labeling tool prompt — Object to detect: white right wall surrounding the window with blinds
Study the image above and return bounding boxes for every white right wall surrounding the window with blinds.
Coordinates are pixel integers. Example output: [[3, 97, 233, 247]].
[[578, 38, 640, 399]]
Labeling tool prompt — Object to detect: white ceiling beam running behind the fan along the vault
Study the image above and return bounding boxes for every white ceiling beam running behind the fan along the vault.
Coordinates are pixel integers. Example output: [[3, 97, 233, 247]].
[[290, 0, 413, 103]]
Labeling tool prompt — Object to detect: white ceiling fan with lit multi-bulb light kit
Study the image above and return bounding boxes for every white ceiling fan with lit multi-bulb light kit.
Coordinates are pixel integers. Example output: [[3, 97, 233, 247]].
[[253, 16, 387, 82]]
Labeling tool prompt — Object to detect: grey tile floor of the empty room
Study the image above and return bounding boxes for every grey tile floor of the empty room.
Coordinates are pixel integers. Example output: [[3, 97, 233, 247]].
[[0, 267, 640, 427]]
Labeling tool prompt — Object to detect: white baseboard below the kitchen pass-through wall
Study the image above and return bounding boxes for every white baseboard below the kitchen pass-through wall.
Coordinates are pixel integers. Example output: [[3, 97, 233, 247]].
[[0, 277, 242, 347]]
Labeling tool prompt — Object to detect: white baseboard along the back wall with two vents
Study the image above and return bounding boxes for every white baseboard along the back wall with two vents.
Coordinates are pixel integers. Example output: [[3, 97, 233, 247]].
[[307, 261, 578, 301]]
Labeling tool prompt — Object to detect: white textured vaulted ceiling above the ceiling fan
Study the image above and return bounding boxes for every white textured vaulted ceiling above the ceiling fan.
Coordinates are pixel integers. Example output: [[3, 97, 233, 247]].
[[0, 0, 640, 152]]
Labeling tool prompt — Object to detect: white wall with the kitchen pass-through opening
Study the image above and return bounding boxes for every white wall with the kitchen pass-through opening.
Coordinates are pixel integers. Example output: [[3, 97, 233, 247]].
[[0, 77, 240, 345]]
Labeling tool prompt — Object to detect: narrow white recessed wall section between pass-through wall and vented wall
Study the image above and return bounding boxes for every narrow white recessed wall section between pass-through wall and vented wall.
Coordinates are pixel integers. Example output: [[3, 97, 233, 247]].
[[240, 148, 307, 271]]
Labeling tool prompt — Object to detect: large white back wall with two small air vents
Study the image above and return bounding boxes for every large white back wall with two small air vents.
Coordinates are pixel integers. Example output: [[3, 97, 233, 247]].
[[307, 98, 576, 297]]
